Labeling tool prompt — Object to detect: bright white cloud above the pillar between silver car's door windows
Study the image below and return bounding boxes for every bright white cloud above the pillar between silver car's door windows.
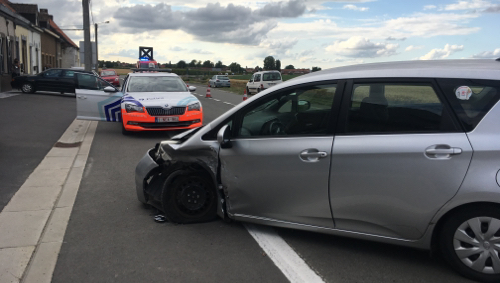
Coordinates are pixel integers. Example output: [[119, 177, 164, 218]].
[[325, 36, 399, 58]]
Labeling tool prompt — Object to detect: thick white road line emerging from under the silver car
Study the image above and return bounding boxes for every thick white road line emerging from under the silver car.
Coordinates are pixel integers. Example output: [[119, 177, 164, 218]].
[[244, 223, 324, 283]]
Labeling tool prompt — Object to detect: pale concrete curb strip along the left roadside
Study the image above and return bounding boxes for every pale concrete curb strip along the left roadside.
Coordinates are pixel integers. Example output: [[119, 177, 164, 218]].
[[0, 120, 97, 282]]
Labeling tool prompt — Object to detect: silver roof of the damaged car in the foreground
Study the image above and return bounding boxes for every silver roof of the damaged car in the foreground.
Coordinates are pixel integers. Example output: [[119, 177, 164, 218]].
[[294, 59, 500, 80]]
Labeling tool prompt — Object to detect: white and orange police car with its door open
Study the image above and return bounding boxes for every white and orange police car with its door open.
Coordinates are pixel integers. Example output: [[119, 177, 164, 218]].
[[75, 72, 203, 135]]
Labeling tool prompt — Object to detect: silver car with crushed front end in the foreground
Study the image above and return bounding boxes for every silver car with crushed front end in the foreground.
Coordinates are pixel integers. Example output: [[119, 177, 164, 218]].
[[136, 60, 500, 282]]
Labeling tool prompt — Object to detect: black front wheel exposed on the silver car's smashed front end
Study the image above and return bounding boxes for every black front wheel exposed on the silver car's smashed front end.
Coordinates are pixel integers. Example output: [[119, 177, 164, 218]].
[[161, 172, 217, 224]]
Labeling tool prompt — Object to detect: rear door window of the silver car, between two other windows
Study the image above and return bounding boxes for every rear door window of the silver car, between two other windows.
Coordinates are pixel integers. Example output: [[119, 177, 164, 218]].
[[346, 83, 456, 133]]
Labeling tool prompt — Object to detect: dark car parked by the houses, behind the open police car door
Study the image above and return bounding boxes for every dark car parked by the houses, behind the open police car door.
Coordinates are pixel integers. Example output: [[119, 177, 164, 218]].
[[10, 69, 94, 93]]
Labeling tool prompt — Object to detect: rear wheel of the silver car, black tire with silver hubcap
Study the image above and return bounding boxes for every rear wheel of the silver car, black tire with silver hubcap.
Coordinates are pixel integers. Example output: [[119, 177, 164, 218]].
[[439, 204, 500, 282]]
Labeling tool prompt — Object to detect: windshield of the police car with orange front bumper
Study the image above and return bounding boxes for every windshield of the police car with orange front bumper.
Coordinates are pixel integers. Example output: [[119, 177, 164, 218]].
[[128, 76, 188, 92]]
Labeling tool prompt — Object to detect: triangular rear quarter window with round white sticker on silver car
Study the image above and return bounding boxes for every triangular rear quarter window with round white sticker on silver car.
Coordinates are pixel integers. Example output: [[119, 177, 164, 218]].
[[438, 79, 500, 131]]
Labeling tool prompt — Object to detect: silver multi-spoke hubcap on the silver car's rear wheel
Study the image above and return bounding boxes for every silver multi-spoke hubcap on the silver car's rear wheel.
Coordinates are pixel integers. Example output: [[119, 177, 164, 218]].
[[453, 217, 500, 274]]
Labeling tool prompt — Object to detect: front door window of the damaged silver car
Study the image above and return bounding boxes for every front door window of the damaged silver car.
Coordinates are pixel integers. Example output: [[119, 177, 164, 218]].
[[238, 84, 337, 138]]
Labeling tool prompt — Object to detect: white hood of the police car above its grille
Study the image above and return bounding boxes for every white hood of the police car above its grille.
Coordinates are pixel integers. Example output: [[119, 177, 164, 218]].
[[123, 92, 199, 107]]
